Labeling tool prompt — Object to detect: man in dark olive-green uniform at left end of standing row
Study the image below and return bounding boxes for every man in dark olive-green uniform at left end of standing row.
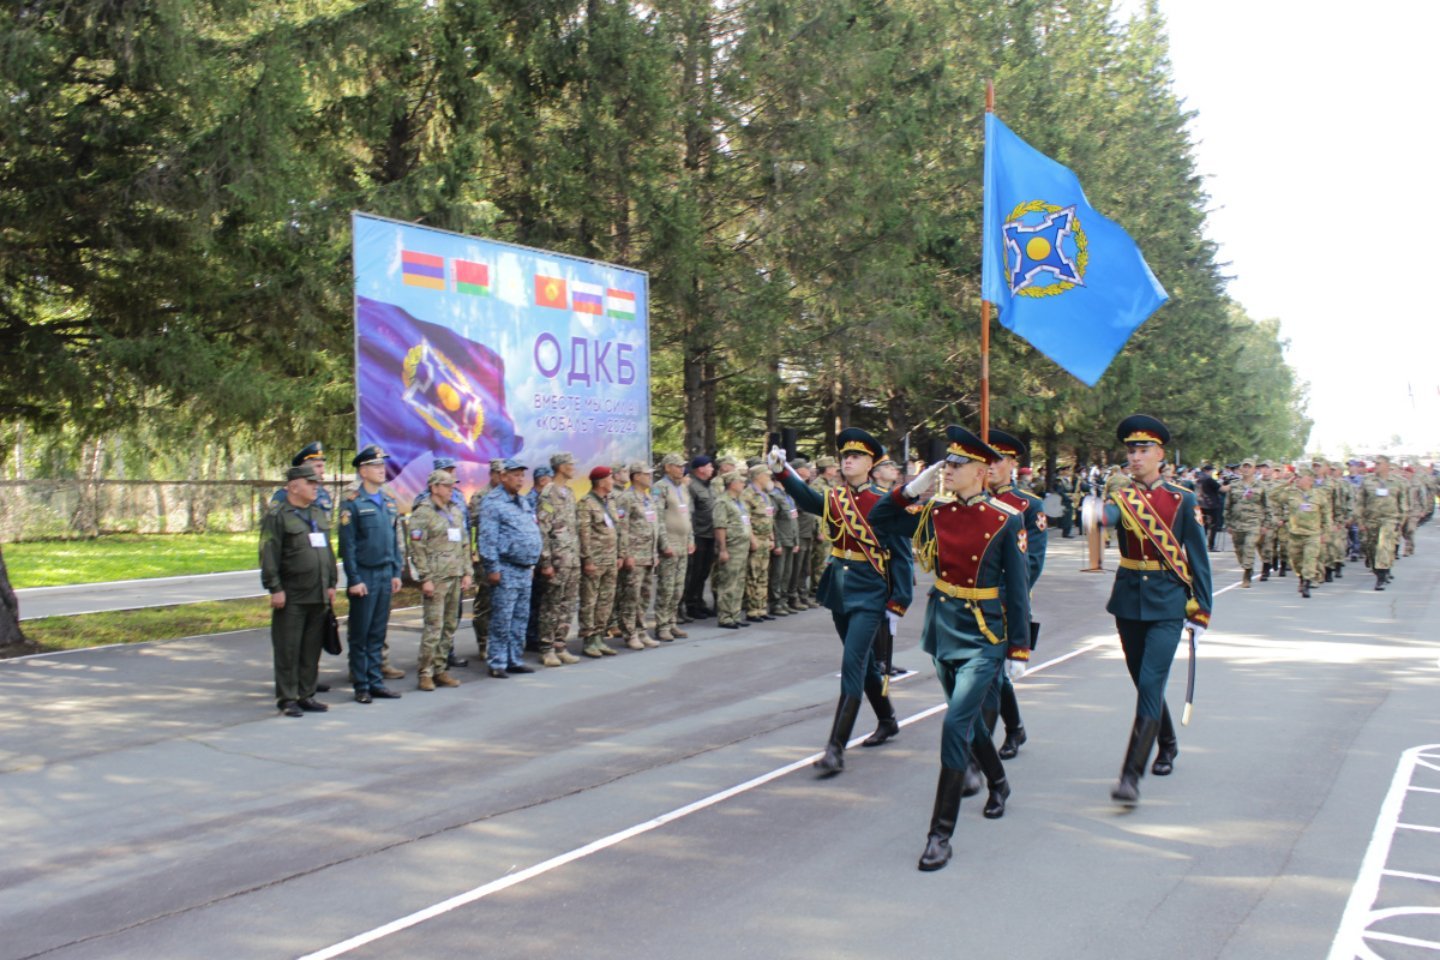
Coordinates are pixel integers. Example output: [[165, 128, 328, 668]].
[[261, 463, 336, 717]]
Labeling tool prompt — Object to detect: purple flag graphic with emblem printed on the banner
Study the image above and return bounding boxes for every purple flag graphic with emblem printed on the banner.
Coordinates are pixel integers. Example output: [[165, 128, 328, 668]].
[[356, 296, 524, 469]]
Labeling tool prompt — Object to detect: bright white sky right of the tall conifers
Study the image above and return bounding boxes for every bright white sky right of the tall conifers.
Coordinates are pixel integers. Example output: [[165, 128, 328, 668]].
[[1123, 0, 1440, 456]]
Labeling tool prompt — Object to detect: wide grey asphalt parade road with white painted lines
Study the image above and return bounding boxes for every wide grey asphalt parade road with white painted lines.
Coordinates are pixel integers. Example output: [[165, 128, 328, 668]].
[[0, 527, 1440, 960]]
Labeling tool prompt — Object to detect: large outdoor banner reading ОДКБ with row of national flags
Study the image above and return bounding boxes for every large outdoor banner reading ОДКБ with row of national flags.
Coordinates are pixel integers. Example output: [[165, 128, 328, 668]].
[[351, 213, 649, 505]]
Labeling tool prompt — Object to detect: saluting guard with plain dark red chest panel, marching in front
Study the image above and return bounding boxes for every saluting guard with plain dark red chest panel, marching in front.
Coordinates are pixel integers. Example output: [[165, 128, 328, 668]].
[[870, 426, 1030, 871]]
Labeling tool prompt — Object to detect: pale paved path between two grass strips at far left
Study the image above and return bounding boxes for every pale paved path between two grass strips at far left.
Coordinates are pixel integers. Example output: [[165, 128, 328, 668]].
[[16, 570, 265, 620]]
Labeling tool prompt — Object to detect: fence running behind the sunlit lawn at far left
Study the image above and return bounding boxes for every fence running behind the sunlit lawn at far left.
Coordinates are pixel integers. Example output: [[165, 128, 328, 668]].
[[0, 481, 338, 543]]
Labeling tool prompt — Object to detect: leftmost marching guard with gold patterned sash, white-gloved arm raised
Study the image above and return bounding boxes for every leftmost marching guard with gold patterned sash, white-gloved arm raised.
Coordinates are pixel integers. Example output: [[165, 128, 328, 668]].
[[769, 427, 914, 776]]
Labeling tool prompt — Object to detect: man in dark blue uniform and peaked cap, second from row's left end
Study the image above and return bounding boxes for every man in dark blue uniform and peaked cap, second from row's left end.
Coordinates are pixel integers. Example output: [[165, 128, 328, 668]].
[[340, 443, 405, 704]]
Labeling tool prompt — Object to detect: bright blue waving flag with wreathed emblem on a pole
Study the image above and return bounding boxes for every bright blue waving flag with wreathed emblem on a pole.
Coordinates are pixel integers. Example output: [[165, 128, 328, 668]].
[[982, 114, 1169, 387]]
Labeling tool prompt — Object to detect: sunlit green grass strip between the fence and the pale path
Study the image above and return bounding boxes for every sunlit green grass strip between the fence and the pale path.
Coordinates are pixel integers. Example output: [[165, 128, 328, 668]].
[[4, 533, 261, 589]]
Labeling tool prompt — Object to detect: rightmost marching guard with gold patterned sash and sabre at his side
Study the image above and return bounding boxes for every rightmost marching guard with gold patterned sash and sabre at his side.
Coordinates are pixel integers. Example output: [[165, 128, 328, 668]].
[[1104, 413, 1211, 806]]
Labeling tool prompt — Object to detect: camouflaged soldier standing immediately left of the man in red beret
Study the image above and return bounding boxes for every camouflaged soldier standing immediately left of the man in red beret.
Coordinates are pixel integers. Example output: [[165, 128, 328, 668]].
[[536, 452, 580, 666]]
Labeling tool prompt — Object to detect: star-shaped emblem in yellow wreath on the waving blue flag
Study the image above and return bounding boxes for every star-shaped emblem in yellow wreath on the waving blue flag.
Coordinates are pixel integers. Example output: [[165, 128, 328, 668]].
[[1002, 200, 1090, 296]]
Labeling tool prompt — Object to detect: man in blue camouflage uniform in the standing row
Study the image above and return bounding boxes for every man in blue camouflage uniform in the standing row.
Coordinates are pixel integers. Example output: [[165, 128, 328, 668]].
[[480, 472, 541, 671]]
